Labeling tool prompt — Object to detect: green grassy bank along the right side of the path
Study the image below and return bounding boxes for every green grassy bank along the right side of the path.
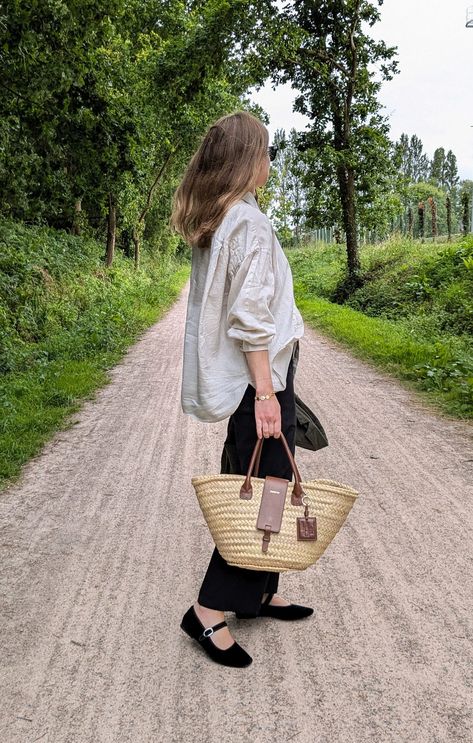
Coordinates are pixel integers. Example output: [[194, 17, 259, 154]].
[[288, 240, 473, 419]]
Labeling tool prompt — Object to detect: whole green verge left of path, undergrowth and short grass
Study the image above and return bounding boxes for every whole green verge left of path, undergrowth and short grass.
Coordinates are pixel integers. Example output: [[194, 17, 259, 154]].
[[0, 218, 190, 489]]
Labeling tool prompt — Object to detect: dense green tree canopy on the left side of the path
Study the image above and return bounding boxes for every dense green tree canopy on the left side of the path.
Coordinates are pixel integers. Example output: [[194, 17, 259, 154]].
[[0, 0, 266, 250]]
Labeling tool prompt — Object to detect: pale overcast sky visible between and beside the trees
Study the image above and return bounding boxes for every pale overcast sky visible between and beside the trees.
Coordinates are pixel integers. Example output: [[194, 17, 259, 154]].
[[251, 0, 473, 179]]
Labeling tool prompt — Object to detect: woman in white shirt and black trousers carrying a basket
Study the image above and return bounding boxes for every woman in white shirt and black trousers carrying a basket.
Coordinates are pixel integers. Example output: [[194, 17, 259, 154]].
[[172, 111, 313, 667]]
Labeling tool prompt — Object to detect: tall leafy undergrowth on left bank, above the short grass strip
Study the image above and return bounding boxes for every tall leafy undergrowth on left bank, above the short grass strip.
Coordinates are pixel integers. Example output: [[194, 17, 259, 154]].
[[0, 222, 188, 374]]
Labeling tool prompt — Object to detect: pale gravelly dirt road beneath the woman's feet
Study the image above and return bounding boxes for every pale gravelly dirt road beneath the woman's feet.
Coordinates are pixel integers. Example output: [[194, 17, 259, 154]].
[[0, 286, 473, 743]]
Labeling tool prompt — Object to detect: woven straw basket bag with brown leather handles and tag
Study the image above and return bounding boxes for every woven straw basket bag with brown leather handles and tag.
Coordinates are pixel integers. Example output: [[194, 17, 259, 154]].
[[191, 433, 358, 572]]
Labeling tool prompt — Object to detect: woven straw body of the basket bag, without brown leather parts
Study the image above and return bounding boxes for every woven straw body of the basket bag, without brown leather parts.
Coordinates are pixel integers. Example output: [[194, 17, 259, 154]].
[[191, 475, 358, 572]]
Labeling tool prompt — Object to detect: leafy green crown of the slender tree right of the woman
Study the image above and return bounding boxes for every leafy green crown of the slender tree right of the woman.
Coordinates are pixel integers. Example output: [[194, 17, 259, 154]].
[[272, 0, 397, 258]]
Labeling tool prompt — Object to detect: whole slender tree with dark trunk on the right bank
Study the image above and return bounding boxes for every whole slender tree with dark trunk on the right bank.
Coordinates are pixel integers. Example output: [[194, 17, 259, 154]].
[[258, 0, 397, 286]]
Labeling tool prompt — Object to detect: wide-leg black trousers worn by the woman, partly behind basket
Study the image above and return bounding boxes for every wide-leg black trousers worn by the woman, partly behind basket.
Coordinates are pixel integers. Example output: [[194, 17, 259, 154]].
[[197, 352, 296, 617]]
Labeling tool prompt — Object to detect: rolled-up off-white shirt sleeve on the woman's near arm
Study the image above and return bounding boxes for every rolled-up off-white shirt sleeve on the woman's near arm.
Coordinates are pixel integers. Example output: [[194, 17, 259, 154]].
[[227, 220, 276, 351]]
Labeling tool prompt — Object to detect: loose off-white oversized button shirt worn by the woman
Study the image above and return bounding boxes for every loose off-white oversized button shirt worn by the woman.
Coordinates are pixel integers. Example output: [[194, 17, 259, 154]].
[[181, 192, 304, 421]]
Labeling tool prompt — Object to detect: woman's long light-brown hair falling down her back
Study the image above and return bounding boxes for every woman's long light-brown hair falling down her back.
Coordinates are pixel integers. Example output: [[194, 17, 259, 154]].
[[171, 111, 269, 248]]
